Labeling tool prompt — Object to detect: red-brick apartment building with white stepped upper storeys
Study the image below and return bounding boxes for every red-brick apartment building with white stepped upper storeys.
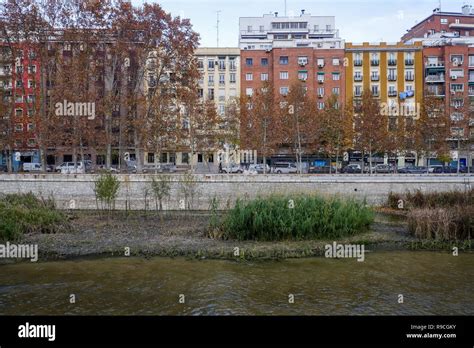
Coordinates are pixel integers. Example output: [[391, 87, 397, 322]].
[[239, 10, 345, 109]]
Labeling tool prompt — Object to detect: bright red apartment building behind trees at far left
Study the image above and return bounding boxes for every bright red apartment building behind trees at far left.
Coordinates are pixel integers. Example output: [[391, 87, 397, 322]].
[[0, 46, 40, 171]]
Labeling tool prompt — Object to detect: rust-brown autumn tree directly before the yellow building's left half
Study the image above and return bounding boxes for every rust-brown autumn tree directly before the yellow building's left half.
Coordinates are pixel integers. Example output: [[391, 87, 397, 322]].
[[354, 90, 388, 174]]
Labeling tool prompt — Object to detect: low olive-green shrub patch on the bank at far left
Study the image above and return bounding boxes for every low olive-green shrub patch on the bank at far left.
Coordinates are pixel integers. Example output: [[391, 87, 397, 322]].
[[0, 193, 69, 241]]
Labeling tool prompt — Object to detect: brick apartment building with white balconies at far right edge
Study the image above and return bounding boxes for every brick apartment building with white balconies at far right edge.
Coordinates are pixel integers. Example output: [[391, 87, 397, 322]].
[[402, 5, 474, 166]]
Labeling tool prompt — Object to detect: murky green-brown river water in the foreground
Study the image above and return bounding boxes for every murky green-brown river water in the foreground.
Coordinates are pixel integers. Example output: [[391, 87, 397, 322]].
[[0, 252, 474, 315]]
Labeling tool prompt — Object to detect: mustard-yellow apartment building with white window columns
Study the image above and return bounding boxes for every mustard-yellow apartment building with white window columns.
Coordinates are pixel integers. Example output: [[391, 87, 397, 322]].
[[345, 42, 423, 166]]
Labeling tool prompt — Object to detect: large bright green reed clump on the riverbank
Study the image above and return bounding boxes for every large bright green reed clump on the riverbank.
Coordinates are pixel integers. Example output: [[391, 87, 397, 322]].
[[222, 195, 373, 241]]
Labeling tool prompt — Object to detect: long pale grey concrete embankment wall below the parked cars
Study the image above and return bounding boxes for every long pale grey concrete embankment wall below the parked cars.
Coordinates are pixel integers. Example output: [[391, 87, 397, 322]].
[[0, 174, 474, 210]]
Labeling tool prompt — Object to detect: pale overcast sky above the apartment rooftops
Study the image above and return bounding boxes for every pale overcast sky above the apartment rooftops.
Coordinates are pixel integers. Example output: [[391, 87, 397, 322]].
[[134, 0, 474, 47]]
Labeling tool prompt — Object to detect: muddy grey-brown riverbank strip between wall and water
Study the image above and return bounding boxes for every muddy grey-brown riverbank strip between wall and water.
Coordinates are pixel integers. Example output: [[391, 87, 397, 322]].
[[1, 211, 471, 262]]
